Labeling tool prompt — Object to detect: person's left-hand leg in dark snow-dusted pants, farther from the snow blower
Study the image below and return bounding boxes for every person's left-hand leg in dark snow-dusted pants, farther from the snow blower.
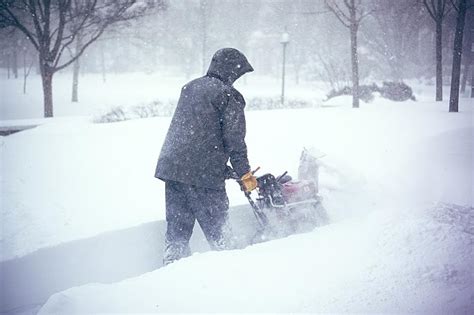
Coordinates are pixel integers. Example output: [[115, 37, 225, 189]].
[[163, 181, 195, 266]]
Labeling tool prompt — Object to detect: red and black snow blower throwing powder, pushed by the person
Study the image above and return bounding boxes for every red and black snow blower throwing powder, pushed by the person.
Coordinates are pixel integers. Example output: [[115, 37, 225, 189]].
[[230, 149, 329, 243]]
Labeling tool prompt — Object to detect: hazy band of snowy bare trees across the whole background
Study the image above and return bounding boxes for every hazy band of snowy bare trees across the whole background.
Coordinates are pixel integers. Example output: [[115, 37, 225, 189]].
[[0, 0, 474, 117]]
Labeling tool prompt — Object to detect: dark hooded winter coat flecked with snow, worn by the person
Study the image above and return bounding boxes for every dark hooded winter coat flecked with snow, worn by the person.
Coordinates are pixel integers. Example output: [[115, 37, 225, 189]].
[[155, 48, 253, 189]]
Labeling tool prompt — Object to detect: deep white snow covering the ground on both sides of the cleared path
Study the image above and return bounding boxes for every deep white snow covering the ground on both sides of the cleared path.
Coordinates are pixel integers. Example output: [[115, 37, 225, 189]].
[[0, 75, 474, 313]]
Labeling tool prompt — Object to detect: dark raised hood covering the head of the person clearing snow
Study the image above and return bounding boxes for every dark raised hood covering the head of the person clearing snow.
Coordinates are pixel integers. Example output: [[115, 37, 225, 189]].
[[207, 48, 253, 85]]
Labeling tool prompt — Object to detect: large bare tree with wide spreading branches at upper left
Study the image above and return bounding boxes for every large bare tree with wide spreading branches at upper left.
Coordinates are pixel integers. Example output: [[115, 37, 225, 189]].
[[0, 0, 152, 117]]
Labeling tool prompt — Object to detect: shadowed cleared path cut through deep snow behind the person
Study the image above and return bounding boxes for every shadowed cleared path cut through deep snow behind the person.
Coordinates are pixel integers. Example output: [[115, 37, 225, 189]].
[[0, 205, 262, 313]]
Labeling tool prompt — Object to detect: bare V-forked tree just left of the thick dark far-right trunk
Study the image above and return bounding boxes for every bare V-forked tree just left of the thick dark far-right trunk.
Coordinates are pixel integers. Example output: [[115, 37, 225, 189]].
[[423, 0, 450, 101]]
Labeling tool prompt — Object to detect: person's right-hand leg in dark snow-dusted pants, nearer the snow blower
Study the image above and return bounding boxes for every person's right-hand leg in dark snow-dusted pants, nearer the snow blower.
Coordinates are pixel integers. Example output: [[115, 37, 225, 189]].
[[188, 186, 234, 250]]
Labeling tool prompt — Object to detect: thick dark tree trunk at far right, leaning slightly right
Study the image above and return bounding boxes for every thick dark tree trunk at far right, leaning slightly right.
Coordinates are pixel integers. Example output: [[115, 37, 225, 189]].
[[449, 0, 466, 112]]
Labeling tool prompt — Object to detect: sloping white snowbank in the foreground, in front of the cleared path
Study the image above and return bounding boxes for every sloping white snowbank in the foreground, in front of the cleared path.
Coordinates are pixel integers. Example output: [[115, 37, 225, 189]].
[[40, 204, 474, 314]]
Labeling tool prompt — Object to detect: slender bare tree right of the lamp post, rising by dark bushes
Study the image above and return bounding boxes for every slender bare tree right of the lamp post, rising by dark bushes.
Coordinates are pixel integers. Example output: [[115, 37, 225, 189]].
[[325, 0, 370, 108]]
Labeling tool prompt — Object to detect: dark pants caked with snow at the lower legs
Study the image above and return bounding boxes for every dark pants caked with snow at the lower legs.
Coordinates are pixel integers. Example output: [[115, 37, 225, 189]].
[[163, 181, 232, 265]]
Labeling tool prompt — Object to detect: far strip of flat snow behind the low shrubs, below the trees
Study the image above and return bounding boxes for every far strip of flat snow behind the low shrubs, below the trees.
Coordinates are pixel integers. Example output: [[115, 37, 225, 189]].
[[0, 72, 325, 122]]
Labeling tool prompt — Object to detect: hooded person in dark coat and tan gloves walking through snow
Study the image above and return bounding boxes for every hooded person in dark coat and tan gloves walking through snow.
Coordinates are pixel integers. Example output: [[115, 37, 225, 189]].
[[155, 48, 257, 265]]
